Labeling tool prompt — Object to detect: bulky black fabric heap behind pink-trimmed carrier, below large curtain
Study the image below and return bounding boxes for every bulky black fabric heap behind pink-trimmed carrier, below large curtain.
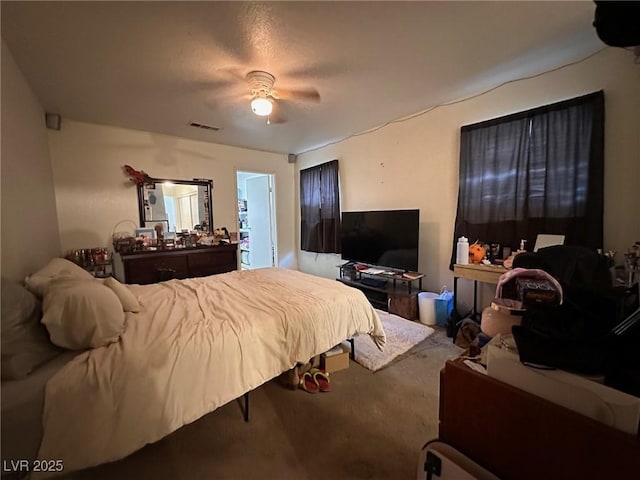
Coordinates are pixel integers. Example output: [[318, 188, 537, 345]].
[[512, 245, 627, 374]]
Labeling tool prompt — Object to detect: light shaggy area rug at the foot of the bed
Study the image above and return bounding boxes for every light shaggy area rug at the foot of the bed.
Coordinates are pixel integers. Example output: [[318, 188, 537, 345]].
[[353, 309, 434, 372]]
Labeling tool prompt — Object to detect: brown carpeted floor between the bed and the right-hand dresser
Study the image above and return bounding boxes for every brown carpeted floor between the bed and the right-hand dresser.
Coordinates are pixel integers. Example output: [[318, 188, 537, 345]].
[[66, 328, 461, 480]]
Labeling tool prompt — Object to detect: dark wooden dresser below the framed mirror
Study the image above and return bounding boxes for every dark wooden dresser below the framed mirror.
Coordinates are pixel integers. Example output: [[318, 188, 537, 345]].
[[113, 244, 238, 285]]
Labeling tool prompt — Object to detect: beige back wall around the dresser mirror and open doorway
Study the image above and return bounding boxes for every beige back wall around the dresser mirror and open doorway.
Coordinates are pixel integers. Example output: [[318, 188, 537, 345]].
[[49, 120, 296, 268]]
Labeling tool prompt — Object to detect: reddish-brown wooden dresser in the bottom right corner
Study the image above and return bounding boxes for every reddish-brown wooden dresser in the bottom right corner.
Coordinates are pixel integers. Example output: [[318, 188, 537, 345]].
[[439, 359, 640, 480]]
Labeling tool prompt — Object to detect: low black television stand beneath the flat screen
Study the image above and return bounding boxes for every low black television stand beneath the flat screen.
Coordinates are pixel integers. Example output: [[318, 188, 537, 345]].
[[336, 264, 424, 320]]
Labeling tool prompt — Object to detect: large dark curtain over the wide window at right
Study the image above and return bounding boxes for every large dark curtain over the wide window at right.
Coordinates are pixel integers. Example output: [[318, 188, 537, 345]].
[[451, 91, 604, 265]]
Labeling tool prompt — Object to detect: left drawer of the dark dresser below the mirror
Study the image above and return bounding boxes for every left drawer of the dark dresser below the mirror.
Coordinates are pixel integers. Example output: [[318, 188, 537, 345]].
[[124, 255, 189, 285]]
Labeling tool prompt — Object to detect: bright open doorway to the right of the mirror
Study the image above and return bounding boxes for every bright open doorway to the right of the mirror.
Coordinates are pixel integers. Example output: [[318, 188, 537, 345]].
[[236, 171, 277, 270]]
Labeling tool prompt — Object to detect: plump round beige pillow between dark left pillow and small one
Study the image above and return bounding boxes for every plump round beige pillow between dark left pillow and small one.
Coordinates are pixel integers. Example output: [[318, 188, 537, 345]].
[[42, 278, 125, 350]]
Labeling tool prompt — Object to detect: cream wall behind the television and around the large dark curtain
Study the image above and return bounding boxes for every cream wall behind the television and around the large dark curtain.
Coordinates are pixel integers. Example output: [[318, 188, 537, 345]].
[[296, 48, 640, 312]]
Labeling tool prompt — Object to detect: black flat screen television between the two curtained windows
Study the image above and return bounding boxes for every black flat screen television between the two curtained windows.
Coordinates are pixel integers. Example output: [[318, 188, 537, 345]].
[[341, 209, 420, 271]]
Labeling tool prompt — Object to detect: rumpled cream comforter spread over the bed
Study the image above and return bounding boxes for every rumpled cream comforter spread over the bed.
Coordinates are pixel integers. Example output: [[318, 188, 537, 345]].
[[39, 268, 385, 472]]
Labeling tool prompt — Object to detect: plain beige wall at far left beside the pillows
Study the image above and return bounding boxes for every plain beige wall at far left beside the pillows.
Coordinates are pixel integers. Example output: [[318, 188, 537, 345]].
[[1, 41, 60, 281]]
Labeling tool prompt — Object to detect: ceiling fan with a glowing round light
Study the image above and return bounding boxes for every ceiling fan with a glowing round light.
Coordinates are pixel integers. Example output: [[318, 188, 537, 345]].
[[246, 70, 320, 125]]
